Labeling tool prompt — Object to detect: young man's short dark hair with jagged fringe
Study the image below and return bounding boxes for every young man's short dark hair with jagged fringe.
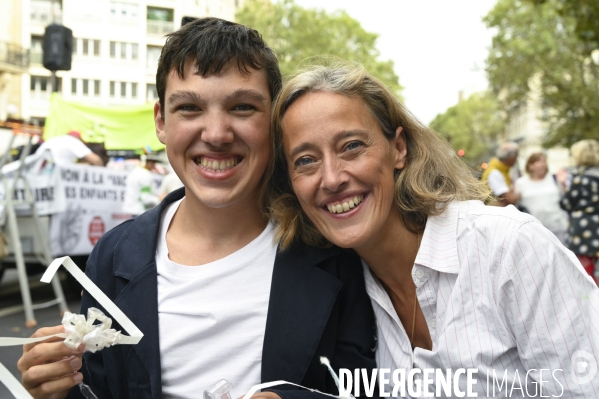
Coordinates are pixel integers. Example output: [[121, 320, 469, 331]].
[[156, 17, 281, 116]]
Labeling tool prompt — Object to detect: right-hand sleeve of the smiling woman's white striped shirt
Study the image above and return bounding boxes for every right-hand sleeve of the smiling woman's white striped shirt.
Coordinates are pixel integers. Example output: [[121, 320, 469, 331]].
[[497, 222, 599, 398]]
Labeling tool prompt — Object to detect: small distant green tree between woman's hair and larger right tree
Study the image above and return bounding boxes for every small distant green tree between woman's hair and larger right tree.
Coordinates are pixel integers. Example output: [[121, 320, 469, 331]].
[[430, 92, 505, 167]]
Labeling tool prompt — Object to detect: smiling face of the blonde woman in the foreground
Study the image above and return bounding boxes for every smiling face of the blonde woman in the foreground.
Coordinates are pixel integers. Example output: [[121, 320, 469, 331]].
[[281, 92, 406, 249]]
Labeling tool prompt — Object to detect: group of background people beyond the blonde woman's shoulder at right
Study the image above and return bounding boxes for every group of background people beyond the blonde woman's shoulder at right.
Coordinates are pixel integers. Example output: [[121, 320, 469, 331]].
[[482, 139, 599, 282]]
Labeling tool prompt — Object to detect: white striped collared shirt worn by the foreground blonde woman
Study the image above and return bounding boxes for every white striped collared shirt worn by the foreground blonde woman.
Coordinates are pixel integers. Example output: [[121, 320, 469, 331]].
[[363, 201, 599, 398]]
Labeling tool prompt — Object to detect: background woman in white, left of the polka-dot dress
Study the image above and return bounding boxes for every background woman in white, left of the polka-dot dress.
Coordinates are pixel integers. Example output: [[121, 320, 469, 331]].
[[514, 152, 568, 243]]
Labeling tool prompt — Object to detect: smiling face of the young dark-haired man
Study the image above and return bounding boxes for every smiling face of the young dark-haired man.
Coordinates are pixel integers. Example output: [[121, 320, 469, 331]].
[[154, 61, 271, 212]]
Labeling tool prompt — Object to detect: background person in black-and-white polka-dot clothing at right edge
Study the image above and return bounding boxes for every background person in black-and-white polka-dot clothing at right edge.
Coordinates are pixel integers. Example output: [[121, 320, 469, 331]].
[[558, 140, 599, 282]]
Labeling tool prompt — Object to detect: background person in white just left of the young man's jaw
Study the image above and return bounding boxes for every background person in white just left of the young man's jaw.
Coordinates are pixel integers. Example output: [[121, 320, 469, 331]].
[[122, 155, 160, 216]]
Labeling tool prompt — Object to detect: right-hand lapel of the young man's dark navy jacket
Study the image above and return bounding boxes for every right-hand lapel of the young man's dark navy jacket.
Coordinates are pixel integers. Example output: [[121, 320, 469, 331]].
[[262, 245, 342, 384]]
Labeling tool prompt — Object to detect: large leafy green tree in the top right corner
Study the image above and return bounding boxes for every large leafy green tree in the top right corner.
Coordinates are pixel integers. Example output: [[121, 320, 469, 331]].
[[484, 0, 599, 146]]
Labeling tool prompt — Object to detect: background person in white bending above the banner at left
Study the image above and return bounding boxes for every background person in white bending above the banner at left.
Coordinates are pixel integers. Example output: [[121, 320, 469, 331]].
[[36, 130, 104, 166]]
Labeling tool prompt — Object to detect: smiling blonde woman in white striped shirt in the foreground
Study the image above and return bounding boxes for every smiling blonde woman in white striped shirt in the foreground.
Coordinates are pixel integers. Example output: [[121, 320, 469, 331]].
[[272, 66, 599, 398]]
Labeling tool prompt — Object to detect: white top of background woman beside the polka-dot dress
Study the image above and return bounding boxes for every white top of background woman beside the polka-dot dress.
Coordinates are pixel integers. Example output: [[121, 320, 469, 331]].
[[515, 173, 568, 242]]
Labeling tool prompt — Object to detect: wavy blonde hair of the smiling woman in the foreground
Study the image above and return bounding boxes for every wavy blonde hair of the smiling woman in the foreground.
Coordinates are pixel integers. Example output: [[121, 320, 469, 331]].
[[269, 63, 493, 249]]
